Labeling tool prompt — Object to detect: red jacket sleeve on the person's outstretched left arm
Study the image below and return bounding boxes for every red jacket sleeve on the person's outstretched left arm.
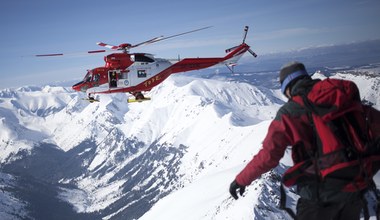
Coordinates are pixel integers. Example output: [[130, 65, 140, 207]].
[[236, 95, 313, 186]]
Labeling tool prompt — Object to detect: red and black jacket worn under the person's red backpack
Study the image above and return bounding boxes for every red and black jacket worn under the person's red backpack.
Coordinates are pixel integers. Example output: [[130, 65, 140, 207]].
[[236, 79, 380, 186]]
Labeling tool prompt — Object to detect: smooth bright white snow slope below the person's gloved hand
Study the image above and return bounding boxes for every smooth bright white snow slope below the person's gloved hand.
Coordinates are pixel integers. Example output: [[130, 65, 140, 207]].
[[140, 169, 242, 219]]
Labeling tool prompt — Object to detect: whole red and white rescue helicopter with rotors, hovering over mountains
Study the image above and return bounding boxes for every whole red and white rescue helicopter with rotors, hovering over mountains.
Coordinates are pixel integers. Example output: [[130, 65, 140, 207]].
[[36, 26, 257, 103]]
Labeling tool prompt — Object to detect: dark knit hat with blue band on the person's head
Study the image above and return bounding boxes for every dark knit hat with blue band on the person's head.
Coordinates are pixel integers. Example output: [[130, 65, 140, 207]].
[[280, 62, 309, 94]]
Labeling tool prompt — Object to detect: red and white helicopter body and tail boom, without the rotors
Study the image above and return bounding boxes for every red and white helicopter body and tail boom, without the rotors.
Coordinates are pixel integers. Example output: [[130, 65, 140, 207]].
[[73, 43, 249, 96]]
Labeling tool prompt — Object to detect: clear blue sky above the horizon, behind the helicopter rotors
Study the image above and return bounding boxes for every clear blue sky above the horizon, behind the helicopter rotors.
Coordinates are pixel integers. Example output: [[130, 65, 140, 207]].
[[0, 0, 380, 89]]
